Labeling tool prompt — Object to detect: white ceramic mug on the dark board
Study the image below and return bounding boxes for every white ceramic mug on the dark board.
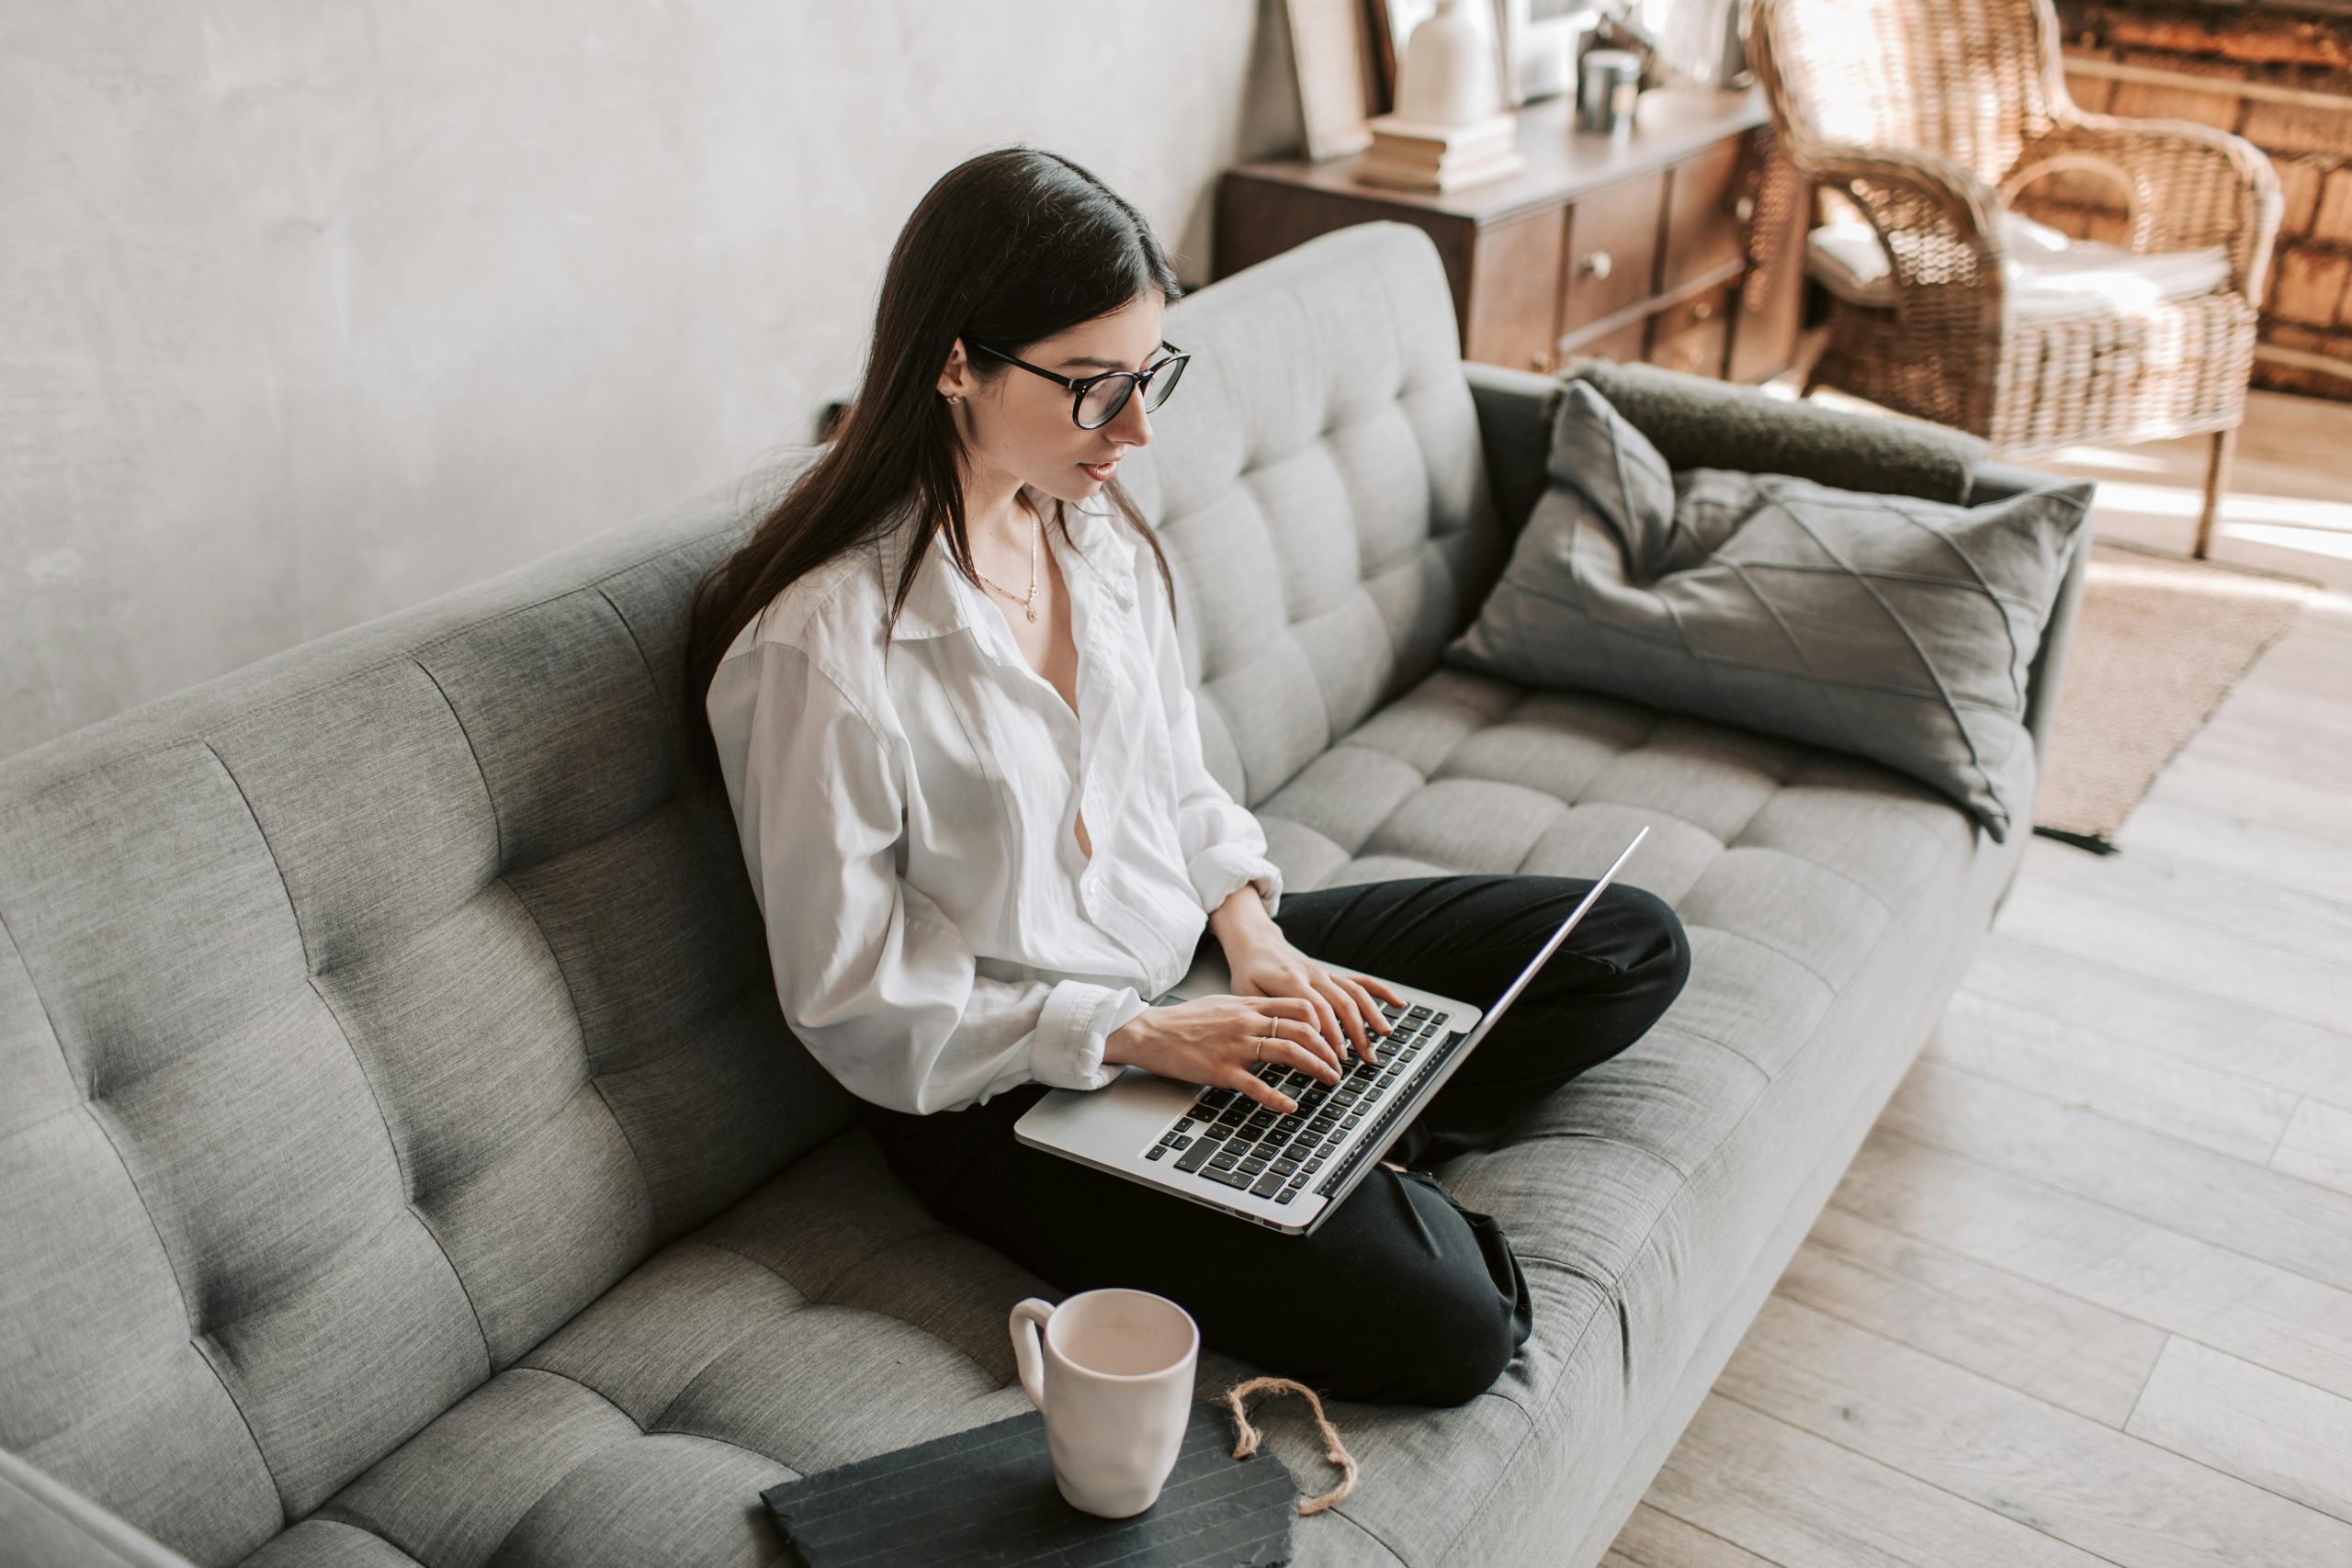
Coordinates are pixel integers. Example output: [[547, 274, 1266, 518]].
[[1012, 1288, 1200, 1518]]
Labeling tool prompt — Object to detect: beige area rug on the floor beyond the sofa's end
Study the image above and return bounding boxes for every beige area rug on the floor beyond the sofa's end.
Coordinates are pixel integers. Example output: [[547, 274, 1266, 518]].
[[2034, 543, 2319, 853]]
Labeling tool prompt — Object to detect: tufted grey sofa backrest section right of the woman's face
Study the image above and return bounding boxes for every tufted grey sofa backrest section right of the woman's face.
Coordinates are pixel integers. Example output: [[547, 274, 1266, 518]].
[[1138, 223, 1510, 807]]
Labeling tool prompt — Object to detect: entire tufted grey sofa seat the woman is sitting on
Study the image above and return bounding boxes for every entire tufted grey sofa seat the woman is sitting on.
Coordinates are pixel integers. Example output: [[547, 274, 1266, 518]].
[[249, 668, 2016, 1568]]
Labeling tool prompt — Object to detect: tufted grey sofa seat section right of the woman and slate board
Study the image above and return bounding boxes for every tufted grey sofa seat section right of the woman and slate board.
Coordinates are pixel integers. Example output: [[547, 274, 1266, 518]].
[[1223, 665, 2020, 1563]]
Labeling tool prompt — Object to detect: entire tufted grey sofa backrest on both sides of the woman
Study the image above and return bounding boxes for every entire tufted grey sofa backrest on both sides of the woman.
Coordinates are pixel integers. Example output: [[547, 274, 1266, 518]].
[[0, 223, 1500, 1563]]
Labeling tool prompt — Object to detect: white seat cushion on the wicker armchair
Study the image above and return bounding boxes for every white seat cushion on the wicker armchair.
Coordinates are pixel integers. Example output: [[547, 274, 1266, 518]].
[[1804, 211, 2230, 322]]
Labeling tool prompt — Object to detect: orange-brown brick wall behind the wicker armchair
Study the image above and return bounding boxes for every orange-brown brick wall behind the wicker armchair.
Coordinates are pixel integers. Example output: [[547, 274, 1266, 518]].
[[2018, 0, 2352, 400]]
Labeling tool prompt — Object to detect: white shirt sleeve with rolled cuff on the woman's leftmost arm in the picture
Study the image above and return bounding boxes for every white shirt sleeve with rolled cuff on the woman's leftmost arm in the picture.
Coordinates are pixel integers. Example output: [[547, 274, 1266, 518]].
[[710, 642, 1146, 1114]]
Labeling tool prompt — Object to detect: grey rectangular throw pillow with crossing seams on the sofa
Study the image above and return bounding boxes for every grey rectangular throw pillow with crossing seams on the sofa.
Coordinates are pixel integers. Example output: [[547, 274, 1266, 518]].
[[1446, 381, 2091, 841]]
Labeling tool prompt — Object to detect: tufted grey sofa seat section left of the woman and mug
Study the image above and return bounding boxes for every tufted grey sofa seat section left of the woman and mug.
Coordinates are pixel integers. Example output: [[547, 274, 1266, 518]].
[[233, 1128, 1244, 1568]]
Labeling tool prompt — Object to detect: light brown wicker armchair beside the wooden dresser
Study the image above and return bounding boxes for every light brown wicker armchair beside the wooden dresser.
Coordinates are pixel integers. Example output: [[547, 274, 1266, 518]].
[[1750, 0, 2281, 555]]
